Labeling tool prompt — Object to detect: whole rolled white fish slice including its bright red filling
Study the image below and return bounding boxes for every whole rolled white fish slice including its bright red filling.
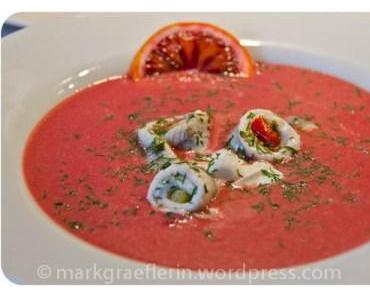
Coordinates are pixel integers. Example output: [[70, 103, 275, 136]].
[[229, 109, 301, 161]]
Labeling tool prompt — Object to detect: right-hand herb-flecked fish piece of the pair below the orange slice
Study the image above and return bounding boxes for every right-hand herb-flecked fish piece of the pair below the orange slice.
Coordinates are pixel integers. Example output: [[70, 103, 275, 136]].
[[165, 110, 209, 152]]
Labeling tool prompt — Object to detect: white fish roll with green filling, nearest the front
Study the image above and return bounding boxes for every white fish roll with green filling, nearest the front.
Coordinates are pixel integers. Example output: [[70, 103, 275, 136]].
[[147, 163, 217, 214]]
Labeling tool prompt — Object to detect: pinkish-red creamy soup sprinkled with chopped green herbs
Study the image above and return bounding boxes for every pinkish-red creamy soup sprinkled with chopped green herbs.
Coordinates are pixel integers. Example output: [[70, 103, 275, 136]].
[[23, 64, 370, 269]]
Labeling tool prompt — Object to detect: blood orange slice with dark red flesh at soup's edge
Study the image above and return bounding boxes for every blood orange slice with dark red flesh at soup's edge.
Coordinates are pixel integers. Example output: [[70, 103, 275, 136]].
[[128, 23, 254, 80]]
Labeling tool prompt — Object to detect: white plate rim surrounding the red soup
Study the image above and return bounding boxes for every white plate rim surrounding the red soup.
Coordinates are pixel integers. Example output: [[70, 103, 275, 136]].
[[2, 13, 370, 283]]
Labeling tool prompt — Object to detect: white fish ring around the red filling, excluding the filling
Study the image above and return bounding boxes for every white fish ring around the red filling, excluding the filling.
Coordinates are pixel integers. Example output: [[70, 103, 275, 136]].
[[229, 109, 301, 161]]
